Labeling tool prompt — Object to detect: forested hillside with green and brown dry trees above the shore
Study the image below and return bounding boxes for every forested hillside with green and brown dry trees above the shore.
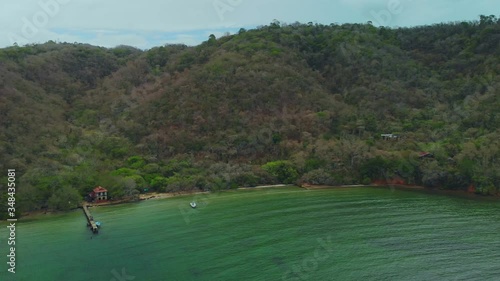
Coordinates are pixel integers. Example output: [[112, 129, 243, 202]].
[[0, 16, 500, 210]]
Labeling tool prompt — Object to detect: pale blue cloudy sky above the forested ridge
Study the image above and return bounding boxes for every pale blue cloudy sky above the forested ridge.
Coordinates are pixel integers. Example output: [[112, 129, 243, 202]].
[[0, 0, 500, 49]]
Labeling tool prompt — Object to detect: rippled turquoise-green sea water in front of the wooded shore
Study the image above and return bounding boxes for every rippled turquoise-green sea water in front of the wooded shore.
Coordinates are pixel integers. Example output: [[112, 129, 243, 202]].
[[0, 188, 500, 281]]
